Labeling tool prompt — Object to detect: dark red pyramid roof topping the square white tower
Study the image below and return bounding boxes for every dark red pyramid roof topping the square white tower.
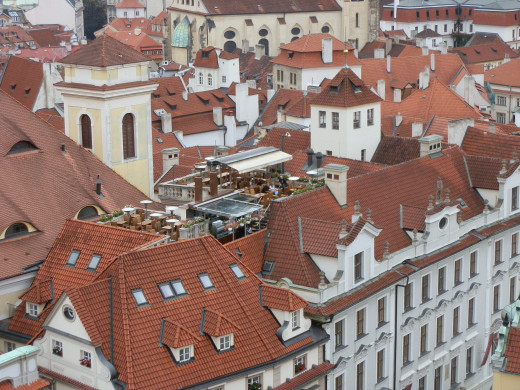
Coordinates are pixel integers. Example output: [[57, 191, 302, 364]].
[[311, 68, 381, 107]]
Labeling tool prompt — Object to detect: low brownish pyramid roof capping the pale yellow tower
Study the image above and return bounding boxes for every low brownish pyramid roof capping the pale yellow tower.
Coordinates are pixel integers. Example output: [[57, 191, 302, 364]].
[[60, 34, 150, 67]]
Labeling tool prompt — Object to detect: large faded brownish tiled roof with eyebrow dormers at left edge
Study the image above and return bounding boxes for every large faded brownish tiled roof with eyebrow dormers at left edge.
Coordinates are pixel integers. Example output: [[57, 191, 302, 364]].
[[0, 92, 161, 278]]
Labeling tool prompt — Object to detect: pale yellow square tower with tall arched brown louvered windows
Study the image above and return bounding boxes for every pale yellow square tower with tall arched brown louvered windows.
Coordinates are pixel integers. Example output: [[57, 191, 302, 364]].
[[56, 35, 157, 197]]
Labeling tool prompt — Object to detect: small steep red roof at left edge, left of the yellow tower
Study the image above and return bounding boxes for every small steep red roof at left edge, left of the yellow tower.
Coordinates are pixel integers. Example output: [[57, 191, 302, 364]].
[[0, 56, 43, 110]]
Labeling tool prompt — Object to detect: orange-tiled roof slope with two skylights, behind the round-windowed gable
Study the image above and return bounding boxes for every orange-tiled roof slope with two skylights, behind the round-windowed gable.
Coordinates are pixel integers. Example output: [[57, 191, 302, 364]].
[[9, 220, 163, 337]]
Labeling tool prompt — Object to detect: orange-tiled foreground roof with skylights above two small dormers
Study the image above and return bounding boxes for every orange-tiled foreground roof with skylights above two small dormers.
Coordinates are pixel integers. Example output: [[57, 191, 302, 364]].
[[66, 236, 313, 390]]
